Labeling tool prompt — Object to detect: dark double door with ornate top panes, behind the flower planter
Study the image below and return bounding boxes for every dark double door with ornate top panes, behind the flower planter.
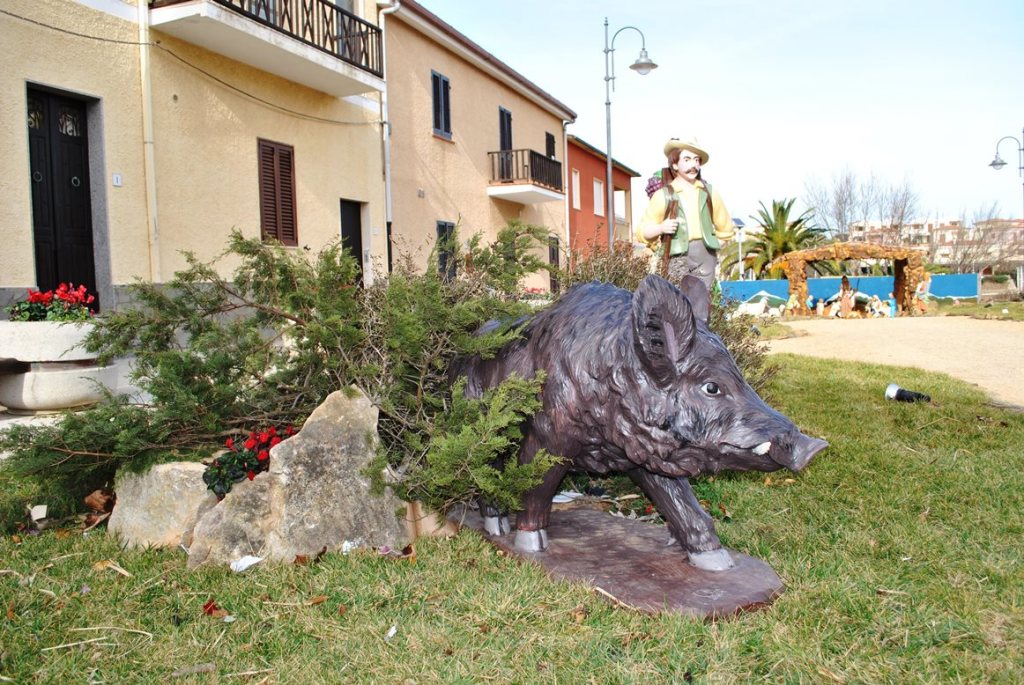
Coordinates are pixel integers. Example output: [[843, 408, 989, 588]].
[[29, 89, 98, 307]]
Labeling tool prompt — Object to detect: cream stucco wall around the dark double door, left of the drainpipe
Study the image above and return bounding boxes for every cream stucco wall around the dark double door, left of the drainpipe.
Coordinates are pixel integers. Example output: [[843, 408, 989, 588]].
[[0, 0, 147, 298]]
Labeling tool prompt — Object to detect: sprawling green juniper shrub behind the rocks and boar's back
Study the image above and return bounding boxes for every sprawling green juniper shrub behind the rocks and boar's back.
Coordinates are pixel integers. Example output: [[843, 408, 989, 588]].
[[0, 223, 546, 520]]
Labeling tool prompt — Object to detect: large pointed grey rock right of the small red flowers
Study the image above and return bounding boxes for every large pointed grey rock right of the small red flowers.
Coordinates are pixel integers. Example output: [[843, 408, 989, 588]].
[[188, 390, 408, 568]]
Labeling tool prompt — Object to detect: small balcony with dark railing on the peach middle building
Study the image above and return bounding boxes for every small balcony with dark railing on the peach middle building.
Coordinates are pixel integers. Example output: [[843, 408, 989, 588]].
[[487, 149, 565, 205]]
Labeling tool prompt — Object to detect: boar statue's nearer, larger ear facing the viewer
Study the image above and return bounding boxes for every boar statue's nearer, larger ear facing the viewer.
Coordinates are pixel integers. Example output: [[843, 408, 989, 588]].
[[633, 274, 697, 385]]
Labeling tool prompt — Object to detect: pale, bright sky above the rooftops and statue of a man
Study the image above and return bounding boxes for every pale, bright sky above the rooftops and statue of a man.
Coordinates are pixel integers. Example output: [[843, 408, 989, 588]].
[[420, 0, 1024, 229]]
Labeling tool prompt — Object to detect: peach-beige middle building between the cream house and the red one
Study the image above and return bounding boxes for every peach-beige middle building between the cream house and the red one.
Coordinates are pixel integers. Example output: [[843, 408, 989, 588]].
[[384, 0, 575, 287]]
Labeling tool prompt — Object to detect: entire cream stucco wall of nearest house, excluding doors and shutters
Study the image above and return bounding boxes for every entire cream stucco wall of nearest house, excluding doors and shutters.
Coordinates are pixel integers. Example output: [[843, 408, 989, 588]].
[[0, 0, 387, 309]]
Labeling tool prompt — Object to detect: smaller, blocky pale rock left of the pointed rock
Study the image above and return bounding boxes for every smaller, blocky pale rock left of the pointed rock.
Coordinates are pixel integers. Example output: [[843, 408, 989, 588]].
[[106, 462, 217, 547]]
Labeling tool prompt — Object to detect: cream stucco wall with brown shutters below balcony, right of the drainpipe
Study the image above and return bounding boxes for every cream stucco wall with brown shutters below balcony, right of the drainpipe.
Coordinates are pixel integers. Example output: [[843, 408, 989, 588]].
[[153, 31, 387, 273]]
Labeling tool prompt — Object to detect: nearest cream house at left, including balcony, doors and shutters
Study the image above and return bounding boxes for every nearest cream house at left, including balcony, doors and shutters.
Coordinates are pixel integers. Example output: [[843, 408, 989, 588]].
[[0, 0, 387, 307]]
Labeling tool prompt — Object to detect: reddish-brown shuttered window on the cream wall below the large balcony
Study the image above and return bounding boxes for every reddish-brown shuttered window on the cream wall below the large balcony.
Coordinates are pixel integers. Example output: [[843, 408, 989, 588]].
[[257, 139, 299, 246]]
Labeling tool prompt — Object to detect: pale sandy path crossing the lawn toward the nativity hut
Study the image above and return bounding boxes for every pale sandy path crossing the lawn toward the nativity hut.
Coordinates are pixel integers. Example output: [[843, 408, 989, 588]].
[[769, 316, 1024, 406]]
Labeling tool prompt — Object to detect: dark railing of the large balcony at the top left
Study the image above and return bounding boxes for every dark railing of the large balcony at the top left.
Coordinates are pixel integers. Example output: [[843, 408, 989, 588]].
[[150, 0, 384, 78]]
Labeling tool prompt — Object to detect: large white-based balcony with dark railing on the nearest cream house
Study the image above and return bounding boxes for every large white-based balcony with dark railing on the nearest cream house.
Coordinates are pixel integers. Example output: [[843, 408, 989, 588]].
[[150, 0, 384, 97]]
